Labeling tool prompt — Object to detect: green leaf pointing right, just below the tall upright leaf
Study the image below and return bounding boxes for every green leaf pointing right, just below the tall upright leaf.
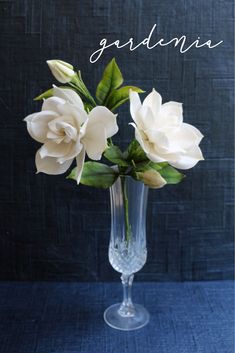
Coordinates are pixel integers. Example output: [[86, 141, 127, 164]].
[[106, 86, 144, 110]]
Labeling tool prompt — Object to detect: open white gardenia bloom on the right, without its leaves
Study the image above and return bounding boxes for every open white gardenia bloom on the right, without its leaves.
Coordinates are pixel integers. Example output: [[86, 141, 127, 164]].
[[130, 89, 204, 169]]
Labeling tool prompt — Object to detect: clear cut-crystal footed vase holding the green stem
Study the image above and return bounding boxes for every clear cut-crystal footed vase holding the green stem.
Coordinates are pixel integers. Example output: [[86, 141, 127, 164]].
[[104, 176, 149, 331]]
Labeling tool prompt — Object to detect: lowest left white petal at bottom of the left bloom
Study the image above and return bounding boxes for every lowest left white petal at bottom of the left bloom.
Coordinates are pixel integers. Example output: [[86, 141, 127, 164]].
[[35, 151, 73, 175]]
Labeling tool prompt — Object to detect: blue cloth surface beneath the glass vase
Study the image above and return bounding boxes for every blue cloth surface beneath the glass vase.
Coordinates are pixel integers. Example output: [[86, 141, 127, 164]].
[[0, 281, 234, 353]]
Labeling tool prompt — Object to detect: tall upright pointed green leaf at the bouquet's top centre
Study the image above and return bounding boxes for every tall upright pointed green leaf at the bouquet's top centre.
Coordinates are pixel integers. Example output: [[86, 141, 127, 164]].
[[96, 58, 123, 105]]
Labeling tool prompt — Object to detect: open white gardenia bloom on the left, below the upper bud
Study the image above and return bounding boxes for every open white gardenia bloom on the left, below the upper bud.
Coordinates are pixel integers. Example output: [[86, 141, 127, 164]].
[[24, 86, 118, 184]]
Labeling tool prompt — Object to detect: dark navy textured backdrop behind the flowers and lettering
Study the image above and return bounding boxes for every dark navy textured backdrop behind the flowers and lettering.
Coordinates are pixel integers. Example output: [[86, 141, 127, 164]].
[[0, 0, 234, 280]]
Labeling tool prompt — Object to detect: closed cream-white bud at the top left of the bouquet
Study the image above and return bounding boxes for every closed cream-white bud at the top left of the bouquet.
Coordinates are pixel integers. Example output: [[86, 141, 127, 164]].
[[47, 60, 75, 83]]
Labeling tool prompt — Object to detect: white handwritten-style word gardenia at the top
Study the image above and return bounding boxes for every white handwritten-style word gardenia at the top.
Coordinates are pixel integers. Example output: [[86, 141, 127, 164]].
[[90, 24, 223, 64]]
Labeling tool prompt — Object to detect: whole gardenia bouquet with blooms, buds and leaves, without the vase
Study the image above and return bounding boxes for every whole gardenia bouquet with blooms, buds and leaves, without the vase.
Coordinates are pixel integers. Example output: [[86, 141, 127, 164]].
[[24, 59, 203, 188]]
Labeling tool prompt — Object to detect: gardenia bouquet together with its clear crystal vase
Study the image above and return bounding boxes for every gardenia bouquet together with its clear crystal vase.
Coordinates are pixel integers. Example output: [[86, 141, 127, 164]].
[[25, 59, 203, 330]]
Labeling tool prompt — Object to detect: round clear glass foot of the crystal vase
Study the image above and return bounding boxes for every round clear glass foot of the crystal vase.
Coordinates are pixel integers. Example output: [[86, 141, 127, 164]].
[[104, 303, 149, 331]]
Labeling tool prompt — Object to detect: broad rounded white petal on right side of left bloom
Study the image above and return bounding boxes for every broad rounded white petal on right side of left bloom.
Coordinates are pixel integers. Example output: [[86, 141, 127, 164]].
[[86, 106, 118, 138]]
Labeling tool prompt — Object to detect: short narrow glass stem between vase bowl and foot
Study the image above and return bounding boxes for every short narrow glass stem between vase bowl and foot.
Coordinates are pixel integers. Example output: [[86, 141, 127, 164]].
[[118, 274, 135, 317]]
